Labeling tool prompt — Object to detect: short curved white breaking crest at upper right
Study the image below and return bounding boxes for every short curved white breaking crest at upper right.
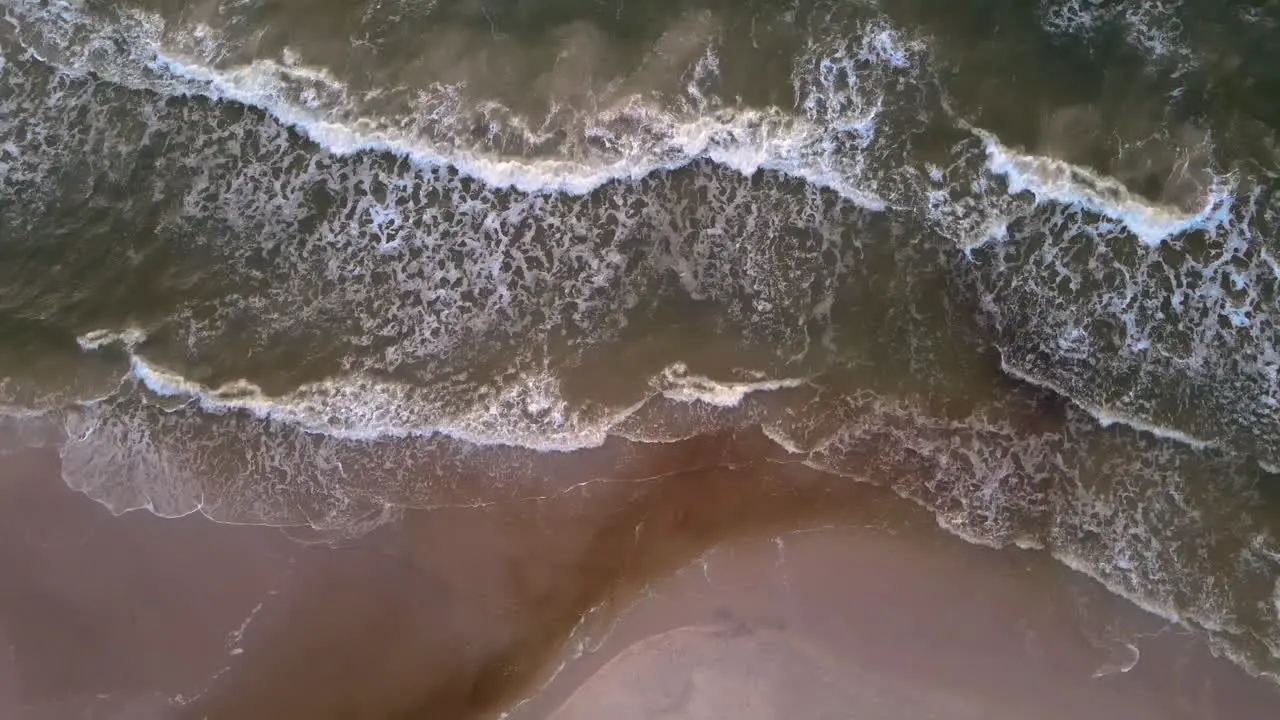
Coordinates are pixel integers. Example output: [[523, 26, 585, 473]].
[[974, 128, 1233, 245]]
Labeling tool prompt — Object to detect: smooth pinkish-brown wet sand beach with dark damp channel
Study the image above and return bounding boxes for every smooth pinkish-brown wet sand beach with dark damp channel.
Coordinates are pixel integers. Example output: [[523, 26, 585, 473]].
[[0, 437, 1280, 720]]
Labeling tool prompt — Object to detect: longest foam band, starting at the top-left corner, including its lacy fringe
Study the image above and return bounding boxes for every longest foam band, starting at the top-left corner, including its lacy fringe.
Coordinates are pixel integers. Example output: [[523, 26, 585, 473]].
[[2, 0, 923, 210]]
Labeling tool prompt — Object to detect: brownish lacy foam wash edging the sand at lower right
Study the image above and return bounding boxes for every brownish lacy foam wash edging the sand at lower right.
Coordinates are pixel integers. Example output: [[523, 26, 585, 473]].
[[805, 389, 1280, 676]]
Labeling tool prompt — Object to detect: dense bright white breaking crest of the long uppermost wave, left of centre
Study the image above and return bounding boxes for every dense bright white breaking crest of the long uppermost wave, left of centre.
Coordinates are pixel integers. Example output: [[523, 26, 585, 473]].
[[147, 26, 901, 210]]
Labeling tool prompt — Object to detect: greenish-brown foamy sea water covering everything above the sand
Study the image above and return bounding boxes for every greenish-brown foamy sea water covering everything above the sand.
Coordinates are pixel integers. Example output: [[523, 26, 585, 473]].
[[0, 0, 1280, 678]]
